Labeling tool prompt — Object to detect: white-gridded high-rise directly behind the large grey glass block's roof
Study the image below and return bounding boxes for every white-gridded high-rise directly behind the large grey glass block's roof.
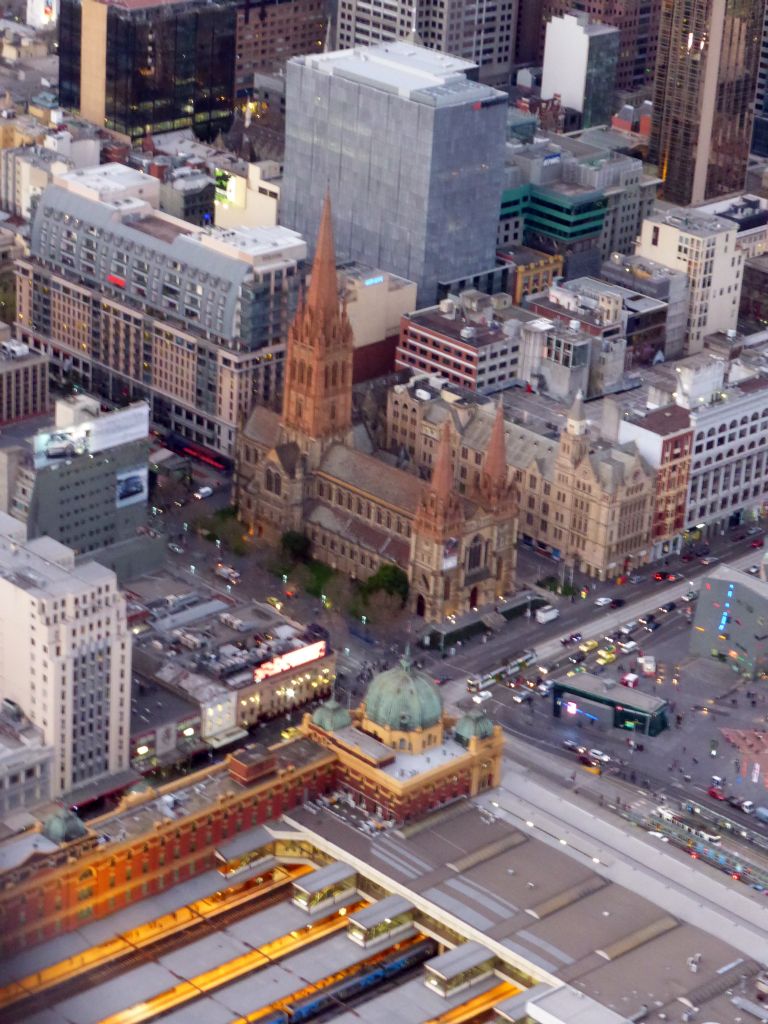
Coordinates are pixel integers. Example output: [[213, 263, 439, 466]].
[[335, 0, 524, 88]]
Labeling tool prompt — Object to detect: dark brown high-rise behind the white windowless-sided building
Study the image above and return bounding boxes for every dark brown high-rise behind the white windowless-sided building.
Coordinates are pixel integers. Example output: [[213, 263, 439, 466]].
[[540, 0, 660, 92]]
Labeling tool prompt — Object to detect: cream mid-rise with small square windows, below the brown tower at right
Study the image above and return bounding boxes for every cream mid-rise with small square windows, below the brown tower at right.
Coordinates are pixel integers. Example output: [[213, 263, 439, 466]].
[[636, 210, 744, 355]]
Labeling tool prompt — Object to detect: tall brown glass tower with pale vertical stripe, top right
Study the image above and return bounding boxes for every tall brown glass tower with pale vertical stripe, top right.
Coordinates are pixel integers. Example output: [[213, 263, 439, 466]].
[[650, 0, 764, 206]]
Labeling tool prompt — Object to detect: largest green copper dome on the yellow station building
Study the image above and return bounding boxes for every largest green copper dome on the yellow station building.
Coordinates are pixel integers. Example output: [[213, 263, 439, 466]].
[[366, 653, 442, 732]]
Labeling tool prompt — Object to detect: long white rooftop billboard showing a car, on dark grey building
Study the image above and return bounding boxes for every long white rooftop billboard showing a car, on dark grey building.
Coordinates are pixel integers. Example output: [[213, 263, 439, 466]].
[[33, 401, 150, 469]]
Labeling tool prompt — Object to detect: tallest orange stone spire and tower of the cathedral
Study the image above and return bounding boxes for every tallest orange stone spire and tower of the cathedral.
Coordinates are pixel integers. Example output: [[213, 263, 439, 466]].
[[282, 196, 353, 450]]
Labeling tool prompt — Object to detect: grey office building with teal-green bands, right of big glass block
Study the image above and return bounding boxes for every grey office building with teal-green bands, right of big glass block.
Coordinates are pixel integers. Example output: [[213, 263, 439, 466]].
[[499, 134, 657, 278]]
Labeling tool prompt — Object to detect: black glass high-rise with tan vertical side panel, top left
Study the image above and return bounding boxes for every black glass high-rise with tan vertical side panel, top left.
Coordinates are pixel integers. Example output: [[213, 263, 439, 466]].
[[58, 0, 236, 139]]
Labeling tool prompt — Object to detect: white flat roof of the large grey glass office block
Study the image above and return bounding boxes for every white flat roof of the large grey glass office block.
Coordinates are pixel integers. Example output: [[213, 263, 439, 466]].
[[293, 41, 507, 106]]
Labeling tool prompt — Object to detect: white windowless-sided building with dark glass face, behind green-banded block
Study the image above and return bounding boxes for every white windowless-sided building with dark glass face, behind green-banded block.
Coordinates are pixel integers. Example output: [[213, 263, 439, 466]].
[[542, 11, 620, 128]]
